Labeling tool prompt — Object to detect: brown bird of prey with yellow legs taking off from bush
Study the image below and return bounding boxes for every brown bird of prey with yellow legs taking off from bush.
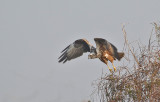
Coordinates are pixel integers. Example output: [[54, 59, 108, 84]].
[[58, 38, 124, 72]]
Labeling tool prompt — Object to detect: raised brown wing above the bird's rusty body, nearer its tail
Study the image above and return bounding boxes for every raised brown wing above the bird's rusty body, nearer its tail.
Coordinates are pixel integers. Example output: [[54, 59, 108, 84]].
[[94, 38, 120, 59]]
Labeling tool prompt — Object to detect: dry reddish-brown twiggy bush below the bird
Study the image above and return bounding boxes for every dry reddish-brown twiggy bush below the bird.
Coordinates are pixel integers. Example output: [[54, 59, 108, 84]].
[[93, 23, 160, 102]]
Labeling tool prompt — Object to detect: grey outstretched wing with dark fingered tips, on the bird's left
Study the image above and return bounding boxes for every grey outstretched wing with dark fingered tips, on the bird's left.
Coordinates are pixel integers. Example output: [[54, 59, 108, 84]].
[[58, 39, 91, 63]]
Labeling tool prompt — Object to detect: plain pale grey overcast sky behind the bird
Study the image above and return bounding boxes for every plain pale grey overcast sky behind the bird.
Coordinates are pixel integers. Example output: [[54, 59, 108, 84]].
[[0, 0, 160, 102]]
